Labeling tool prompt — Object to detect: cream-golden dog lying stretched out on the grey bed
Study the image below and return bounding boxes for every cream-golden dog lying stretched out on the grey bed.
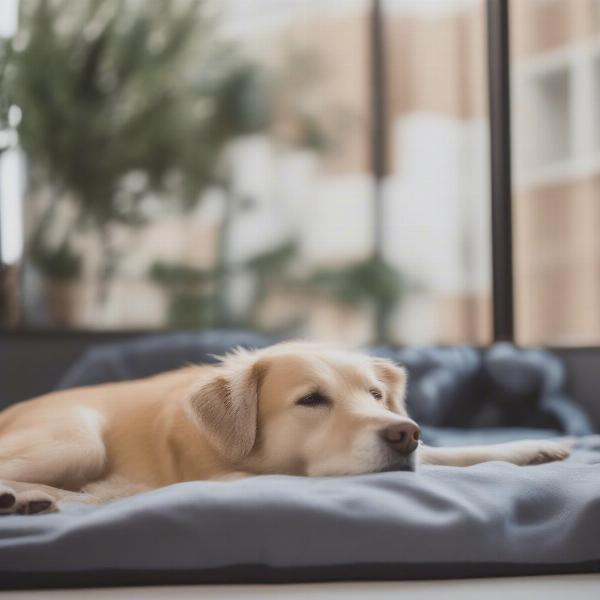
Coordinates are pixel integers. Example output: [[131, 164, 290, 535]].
[[0, 342, 569, 514]]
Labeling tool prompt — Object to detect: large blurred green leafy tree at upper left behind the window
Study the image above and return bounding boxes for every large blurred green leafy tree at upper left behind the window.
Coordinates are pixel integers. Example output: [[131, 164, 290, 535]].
[[0, 0, 263, 308]]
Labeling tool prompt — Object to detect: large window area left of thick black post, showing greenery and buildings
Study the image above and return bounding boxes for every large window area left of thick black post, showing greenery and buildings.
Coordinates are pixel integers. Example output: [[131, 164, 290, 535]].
[[0, 0, 490, 343]]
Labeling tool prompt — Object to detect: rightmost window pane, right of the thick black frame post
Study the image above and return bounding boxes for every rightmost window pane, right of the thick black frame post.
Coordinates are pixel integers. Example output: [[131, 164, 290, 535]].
[[510, 0, 600, 345]]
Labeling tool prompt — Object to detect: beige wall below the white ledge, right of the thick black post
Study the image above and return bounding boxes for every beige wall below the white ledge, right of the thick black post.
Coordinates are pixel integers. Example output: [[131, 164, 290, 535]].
[[514, 176, 600, 344]]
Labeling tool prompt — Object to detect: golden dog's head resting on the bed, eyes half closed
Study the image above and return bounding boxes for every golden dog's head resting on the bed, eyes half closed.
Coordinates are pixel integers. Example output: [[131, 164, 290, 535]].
[[188, 342, 420, 475]]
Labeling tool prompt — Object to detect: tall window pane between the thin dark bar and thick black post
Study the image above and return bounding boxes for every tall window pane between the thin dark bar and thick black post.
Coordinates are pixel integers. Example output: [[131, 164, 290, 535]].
[[384, 0, 491, 343]]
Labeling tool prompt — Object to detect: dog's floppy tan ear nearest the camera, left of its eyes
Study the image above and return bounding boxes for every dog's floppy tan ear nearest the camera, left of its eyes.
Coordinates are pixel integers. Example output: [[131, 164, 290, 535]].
[[188, 352, 265, 462]]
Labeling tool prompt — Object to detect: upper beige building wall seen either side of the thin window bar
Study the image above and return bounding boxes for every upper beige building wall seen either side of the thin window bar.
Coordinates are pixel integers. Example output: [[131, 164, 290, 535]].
[[279, 2, 487, 174]]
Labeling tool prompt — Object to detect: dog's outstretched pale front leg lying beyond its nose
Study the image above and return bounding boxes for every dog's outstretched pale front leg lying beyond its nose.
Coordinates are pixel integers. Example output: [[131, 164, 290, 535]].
[[419, 440, 571, 467]]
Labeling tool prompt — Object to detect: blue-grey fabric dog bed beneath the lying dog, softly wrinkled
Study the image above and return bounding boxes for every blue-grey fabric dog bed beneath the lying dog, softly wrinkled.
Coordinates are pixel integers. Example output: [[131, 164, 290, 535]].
[[0, 436, 600, 588]]
